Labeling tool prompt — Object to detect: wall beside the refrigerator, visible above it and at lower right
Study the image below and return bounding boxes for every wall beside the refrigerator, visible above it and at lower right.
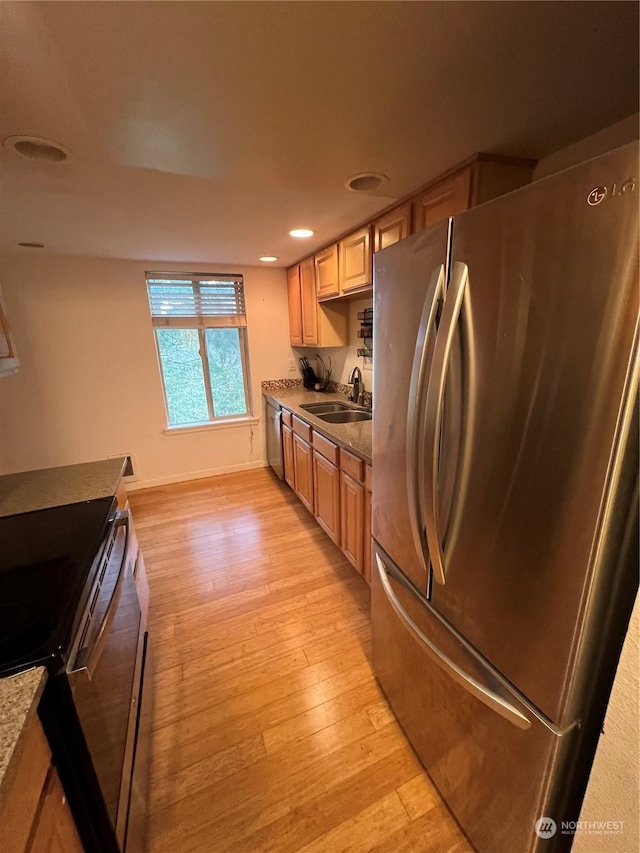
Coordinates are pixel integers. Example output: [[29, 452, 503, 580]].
[[534, 115, 640, 853]]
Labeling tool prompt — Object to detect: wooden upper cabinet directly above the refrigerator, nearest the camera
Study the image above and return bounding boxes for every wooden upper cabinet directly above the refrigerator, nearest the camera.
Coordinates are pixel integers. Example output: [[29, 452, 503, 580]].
[[413, 154, 535, 232]]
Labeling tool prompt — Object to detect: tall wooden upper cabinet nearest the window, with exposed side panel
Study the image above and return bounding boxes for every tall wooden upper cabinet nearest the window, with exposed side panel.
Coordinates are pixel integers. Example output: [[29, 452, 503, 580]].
[[287, 258, 349, 347]]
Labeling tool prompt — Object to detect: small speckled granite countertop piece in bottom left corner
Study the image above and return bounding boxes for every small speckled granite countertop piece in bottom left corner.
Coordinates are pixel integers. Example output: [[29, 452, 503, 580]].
[[0, 666, 47, 797]]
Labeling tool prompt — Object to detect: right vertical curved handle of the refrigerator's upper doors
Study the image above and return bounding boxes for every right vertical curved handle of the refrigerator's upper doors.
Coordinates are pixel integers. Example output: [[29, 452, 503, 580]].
[[420, 261, 469, 584]]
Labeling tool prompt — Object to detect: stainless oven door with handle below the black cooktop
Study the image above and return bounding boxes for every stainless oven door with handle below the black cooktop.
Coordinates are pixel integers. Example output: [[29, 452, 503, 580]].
[[67, 512, 142, 850]]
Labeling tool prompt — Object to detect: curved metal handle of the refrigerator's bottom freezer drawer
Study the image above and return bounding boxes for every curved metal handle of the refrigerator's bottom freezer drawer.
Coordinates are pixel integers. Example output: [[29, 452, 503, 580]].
[[376, 554, 531, 730]]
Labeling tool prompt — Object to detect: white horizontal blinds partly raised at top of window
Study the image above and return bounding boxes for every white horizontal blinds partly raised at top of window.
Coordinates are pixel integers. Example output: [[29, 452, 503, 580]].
[[146, 272, 247, 327]]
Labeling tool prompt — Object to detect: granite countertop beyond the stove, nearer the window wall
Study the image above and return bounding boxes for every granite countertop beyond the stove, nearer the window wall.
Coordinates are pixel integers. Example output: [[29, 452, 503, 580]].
[[0, 456, 126, 516]]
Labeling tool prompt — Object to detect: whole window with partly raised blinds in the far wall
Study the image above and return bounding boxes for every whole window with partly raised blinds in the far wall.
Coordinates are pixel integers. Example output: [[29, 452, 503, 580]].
[[147, 272, 250, 427]]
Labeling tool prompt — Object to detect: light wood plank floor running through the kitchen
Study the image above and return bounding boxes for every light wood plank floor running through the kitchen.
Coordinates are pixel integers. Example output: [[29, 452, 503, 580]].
[[130, 469, 470, 853]]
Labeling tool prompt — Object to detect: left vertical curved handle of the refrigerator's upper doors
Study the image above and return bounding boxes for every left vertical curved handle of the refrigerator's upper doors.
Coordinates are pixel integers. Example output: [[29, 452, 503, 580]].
[[406, 264, 445, 570]]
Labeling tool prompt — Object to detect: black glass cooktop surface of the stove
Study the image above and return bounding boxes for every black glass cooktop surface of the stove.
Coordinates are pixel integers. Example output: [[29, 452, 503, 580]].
[[0, 497, 115, 676]]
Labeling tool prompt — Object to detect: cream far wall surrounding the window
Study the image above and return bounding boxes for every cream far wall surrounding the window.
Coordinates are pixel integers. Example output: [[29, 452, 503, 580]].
[[0, 250, 294, 485]]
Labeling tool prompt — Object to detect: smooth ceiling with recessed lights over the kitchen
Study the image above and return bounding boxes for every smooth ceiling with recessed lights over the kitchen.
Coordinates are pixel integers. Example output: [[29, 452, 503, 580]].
[[0, 0, 638, 265]]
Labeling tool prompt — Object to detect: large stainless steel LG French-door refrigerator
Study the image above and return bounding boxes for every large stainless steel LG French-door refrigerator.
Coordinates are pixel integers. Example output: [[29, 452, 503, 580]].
[[372, 144, 640, 853]]
